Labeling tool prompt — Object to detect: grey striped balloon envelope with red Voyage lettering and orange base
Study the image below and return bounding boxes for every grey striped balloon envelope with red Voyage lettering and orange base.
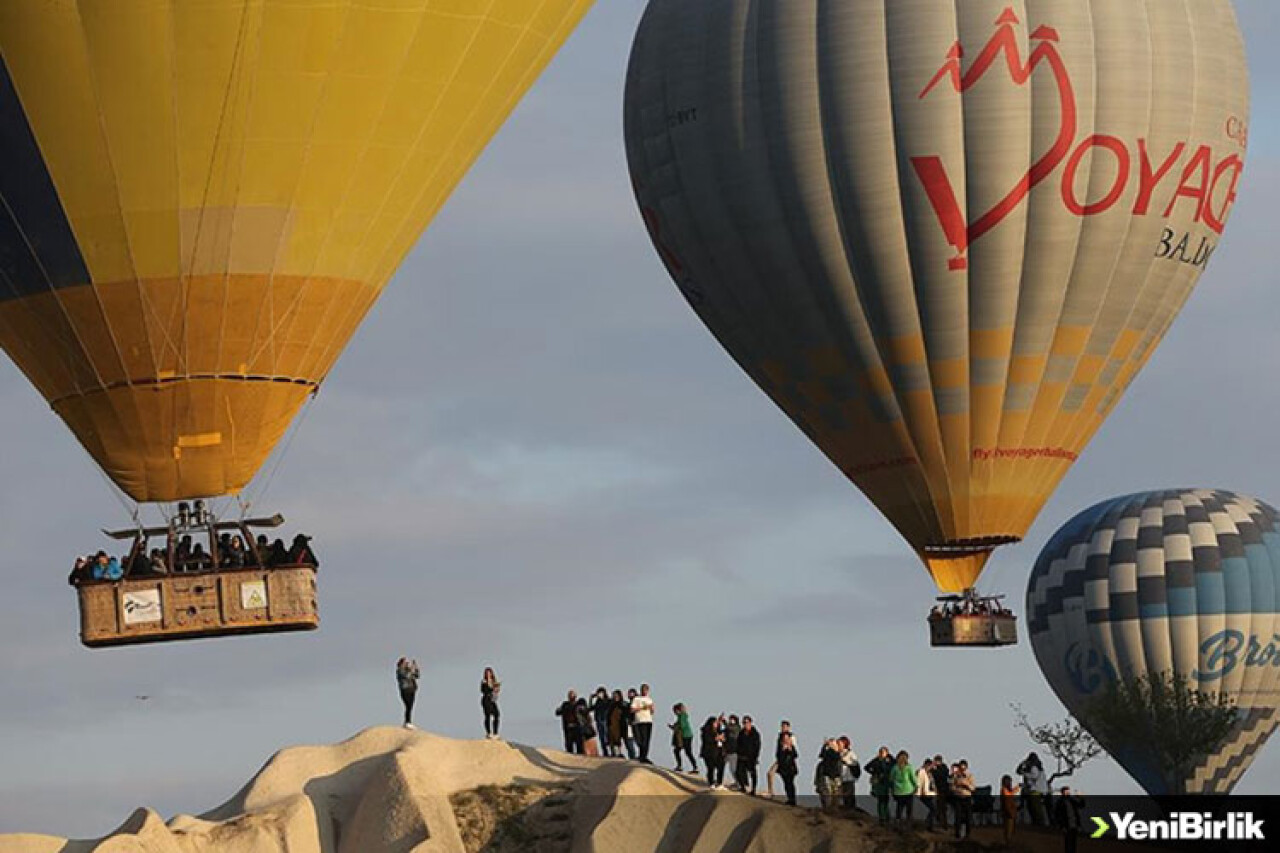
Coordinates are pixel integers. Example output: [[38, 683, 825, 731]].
[[626, 0, 1248, 637]]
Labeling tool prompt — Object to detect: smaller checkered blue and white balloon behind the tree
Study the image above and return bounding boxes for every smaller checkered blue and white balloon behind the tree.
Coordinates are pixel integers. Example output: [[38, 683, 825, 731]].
[[1027, 489, 1280, 795]]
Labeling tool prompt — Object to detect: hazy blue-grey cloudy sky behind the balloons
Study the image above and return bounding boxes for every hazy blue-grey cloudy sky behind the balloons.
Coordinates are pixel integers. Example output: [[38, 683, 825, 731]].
[[0, 0, 1280, 838]]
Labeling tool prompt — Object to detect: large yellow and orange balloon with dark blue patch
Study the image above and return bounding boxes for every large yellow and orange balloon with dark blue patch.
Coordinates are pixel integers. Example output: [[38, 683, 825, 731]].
[[0, 0, 591, 635]]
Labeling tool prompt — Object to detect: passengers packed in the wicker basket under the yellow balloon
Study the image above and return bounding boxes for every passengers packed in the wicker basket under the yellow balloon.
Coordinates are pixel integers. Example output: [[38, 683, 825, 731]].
[[67, 533, 320, 585]]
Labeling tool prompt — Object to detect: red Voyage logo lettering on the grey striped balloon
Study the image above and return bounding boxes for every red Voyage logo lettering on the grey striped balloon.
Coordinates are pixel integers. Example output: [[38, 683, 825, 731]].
[[911, 8, 1244, 270]]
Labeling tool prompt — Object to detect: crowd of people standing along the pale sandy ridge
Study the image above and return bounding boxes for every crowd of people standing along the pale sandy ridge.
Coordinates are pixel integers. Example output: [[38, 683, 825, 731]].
[[396, 657, 1084, 852]]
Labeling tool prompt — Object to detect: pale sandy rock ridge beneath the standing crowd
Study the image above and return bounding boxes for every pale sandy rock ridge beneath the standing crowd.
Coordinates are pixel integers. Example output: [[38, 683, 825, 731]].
[[0, 727, 1172, 853]]
